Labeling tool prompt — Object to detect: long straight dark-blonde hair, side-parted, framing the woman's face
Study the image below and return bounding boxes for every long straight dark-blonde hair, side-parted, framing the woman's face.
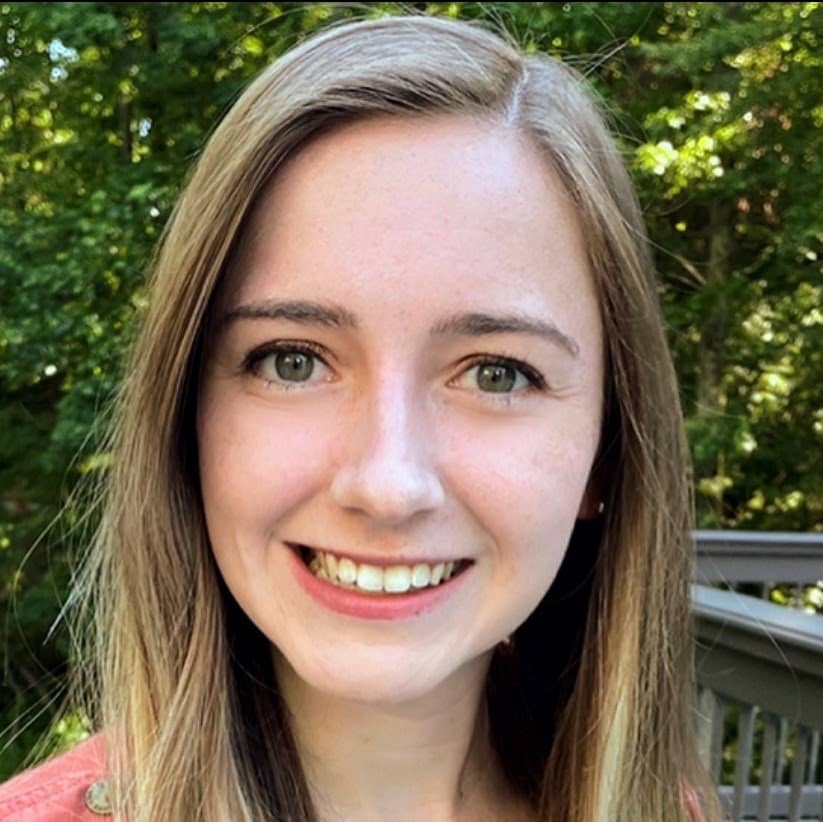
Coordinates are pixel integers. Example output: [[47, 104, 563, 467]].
[[78, 16, 713, 822]]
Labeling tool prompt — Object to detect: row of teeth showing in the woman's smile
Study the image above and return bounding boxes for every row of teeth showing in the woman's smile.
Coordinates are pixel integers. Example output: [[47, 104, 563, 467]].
[[309, 551, 466, 594]]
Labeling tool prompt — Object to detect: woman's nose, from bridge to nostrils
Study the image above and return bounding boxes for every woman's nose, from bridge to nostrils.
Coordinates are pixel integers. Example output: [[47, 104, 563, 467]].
[[331, 380, 444, 525]]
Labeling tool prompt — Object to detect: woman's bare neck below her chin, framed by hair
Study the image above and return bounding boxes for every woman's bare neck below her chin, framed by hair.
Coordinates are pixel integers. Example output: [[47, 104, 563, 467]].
[[275, 654, 512, 822]]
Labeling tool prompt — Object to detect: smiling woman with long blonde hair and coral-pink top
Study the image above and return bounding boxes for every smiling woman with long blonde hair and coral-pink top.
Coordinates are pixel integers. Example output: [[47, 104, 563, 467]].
[[0, 12, 715, 822]]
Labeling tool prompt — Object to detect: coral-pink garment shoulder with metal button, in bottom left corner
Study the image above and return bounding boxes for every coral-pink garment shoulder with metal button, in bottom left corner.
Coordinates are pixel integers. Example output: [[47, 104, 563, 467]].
[[0, 734, 109, 822]]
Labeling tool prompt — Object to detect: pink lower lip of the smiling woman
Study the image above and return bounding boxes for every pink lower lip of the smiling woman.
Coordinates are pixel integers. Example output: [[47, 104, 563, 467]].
[[288, 546, 471, 620]]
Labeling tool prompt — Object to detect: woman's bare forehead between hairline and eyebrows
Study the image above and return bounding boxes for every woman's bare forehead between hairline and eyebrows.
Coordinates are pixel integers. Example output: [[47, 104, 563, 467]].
[[227, 116, 594, 340]]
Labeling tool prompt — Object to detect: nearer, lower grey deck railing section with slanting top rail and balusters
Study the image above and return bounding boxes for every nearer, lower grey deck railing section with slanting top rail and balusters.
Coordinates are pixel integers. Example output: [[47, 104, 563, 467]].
[[692, 585, 823, 822]]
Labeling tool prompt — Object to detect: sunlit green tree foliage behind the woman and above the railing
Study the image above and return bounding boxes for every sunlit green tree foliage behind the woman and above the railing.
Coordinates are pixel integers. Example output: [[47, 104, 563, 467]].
[[0, 3, 823, 778]]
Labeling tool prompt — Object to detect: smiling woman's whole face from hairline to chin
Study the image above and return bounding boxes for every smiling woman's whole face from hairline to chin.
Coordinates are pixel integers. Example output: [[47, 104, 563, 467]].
[[197, 117, 603, 702]]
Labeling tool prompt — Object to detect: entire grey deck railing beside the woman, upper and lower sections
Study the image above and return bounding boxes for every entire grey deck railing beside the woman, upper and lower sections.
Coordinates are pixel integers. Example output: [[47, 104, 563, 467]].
[[692, 531, 823, 822]]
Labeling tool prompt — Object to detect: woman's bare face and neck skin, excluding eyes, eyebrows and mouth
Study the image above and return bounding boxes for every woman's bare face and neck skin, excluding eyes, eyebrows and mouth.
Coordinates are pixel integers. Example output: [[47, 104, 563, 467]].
[[198, 116, 603, 822]]
